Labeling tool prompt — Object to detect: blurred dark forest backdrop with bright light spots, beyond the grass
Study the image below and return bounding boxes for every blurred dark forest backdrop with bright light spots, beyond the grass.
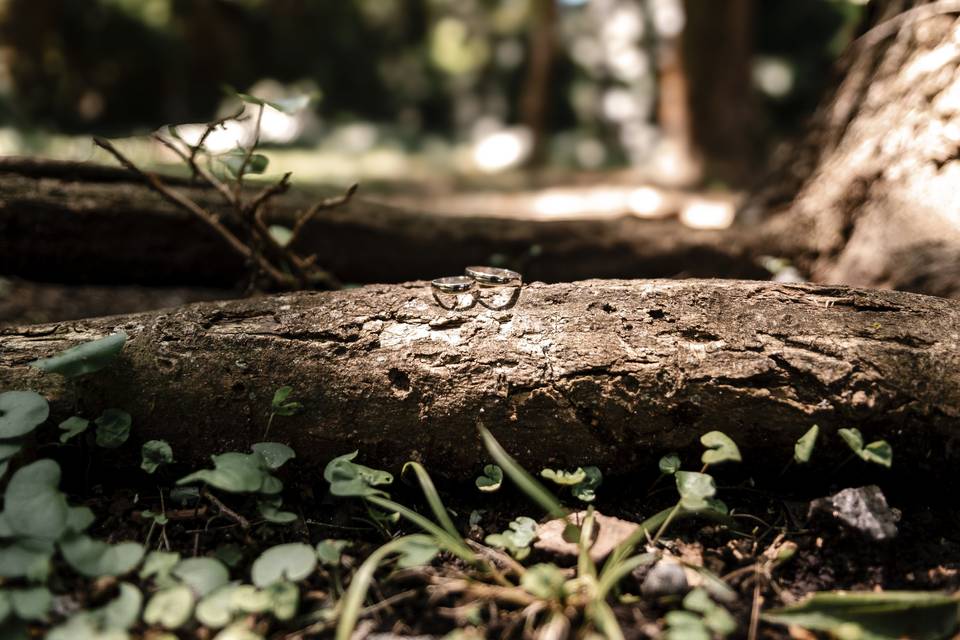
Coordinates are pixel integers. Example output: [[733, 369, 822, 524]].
[[0, 0, 862, 182]]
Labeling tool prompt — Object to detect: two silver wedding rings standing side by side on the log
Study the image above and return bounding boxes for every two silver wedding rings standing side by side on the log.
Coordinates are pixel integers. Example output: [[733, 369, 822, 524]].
[[430, 267, 523, 311]]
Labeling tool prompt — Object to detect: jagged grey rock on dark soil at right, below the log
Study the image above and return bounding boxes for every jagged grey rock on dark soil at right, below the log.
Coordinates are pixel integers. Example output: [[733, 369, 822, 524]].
[[807, 485, 900, 541]]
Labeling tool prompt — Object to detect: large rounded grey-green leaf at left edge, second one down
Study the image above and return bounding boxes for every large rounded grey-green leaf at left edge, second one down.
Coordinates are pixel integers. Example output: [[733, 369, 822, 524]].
[[4, 459, 69, 540]]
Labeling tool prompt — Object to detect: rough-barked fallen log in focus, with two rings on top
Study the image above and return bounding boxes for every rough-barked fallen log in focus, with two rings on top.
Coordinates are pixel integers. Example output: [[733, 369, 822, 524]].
[[0, 280, 960, 478]]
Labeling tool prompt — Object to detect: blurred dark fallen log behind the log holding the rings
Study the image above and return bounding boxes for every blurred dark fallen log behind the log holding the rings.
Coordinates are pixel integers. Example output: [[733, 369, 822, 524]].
[[0, 160, 764, 287]]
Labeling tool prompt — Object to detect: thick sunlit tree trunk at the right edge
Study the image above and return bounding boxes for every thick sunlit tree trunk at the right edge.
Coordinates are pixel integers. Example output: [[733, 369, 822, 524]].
[[761, 1, 960, 297]]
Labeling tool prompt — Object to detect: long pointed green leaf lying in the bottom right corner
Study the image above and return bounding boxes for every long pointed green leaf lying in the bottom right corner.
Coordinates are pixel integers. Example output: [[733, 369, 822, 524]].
[[762, 591, 960, 640]]
